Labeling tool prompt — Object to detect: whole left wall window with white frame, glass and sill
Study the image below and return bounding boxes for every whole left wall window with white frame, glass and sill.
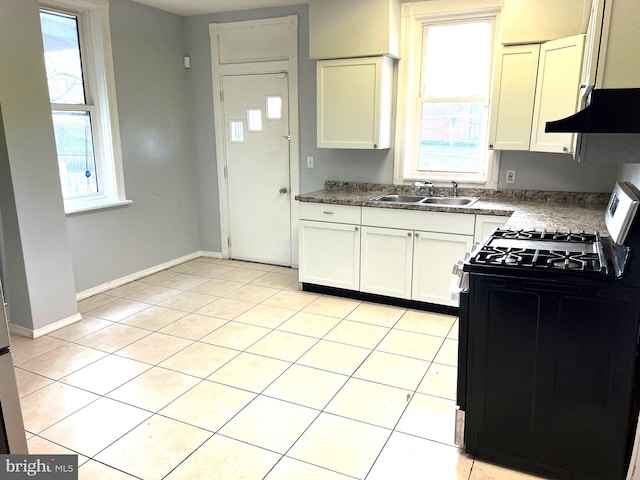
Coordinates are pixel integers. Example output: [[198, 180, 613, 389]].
[[40, 0, 128, 213]]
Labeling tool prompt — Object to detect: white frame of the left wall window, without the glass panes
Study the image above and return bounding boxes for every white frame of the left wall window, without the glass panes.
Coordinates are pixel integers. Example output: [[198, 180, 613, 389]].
[[40, 0, 131, 214]]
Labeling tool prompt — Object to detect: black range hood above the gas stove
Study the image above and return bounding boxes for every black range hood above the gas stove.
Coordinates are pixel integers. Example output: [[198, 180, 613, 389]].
[[544, 88, 640, 133]]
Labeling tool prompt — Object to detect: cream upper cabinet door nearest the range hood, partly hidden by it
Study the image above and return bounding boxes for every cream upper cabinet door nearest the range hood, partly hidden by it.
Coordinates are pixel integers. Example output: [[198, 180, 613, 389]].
[[530, 35, 585, 153]]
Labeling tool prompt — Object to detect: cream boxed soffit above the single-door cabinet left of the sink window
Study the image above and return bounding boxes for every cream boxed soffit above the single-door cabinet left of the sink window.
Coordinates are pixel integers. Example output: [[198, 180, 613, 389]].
[[309, 0, 400, 60]]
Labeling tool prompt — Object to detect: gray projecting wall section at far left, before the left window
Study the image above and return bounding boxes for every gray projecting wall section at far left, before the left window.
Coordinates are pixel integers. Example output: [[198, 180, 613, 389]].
[[0, 0, 77, 329]]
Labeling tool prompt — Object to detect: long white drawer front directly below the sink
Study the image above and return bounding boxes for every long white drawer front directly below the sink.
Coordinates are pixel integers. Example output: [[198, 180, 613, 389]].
[[362, 207, 475, 235]]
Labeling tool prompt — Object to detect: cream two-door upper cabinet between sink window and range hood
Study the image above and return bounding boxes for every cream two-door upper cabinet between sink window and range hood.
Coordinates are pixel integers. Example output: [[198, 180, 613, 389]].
[[489, 35, 585, 153]]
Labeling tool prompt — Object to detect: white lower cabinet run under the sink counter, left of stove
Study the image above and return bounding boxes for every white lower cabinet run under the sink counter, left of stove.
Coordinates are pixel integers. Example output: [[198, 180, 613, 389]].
[[299, 202, 509, 307]]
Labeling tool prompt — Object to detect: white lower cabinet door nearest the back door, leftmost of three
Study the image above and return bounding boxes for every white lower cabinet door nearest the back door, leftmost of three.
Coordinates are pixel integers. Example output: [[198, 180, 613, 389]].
[[299, 220, 360, 290]]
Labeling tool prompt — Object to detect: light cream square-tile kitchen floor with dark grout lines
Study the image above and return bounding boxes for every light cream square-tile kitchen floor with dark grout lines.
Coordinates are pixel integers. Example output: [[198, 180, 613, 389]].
[[12, 258, 552, 480]]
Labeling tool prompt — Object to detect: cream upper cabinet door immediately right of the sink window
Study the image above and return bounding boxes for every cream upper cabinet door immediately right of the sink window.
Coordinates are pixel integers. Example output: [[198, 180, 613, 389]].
[[489, 44, 540, 150]]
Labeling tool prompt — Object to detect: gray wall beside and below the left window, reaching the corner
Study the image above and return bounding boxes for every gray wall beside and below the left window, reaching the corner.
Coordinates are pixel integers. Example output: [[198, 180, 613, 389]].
[[67, 0, 200, 291]]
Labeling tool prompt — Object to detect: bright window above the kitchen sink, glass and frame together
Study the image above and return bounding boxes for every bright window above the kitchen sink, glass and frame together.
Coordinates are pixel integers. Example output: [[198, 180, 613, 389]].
[[395, 0, 498, 186]]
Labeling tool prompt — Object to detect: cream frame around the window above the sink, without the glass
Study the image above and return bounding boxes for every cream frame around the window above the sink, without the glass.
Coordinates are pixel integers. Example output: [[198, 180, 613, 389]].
[[393, 0, 502, 188]]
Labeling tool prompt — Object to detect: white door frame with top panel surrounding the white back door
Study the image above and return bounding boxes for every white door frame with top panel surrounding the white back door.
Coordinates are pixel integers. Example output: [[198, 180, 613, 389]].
[[209, 15, 300, 267]]
